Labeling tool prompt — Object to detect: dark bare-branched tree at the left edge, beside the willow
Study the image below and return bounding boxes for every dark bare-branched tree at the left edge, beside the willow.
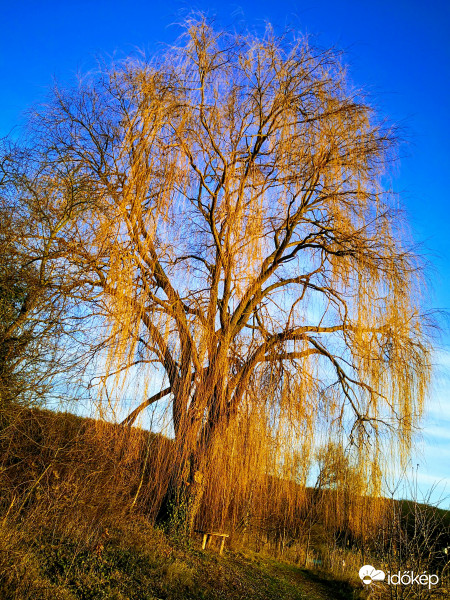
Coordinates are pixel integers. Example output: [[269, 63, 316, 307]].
[[0, 142, 80, 416]]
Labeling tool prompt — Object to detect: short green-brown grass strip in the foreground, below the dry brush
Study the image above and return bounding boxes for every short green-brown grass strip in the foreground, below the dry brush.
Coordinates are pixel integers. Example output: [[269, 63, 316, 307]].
[[0, 510, 363, 600]]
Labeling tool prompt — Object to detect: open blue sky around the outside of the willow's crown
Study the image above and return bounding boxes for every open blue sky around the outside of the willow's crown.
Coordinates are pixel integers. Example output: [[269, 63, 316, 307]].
[[0, 0, 450, 506]]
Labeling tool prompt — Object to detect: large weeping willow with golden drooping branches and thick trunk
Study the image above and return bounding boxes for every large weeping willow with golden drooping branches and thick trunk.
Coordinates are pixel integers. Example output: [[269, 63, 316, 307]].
[[22, 20, 429, 528]]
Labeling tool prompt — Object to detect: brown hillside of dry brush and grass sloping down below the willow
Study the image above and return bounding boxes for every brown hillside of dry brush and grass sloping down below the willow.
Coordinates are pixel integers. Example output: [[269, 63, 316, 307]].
[[0, 409, 449, 600]]
